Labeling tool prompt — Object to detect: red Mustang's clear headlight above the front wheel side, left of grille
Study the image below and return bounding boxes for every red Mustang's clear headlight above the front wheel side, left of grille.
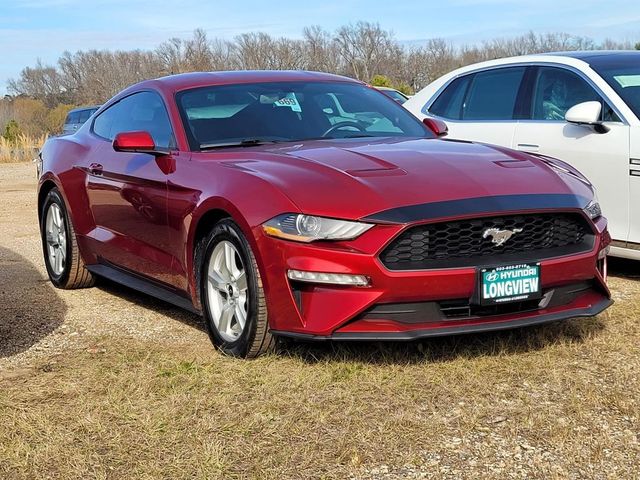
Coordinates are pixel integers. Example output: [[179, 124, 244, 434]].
[[262, 213, 373, 242]]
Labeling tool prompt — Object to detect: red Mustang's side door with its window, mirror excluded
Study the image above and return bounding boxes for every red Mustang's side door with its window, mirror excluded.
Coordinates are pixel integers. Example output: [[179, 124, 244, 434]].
[[86, 92, 174, 281]]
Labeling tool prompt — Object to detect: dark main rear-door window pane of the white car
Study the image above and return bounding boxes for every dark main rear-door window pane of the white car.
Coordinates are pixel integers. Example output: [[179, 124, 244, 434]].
[[462, 67, 526, 120]]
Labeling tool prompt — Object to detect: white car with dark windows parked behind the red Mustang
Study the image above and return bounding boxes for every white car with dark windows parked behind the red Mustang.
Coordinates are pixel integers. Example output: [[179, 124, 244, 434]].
[[404, 51, 640, 259]]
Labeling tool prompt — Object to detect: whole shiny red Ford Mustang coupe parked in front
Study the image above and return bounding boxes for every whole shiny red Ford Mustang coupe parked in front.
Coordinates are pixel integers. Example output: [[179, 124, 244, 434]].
[[38, 72, 611, 356]]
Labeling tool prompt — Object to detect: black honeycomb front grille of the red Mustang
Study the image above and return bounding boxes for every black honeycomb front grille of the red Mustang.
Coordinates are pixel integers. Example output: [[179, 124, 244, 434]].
[[380, 213, 594, 270]]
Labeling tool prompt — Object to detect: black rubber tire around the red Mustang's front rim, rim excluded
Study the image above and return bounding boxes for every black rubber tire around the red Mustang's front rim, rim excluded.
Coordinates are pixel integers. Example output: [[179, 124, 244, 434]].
[[195, 218, 275, 358]]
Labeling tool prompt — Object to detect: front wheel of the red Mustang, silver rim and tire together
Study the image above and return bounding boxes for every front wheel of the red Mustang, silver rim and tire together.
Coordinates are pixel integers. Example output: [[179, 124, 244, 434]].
[[197, 219, 275, 357]]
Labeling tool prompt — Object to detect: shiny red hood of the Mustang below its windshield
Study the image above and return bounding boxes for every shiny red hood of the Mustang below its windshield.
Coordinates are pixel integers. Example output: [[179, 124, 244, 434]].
[[215, 138, 593, 219]]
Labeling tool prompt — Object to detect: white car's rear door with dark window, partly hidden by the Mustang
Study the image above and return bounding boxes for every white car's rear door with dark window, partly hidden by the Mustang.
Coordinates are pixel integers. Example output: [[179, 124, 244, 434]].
[[423, 66, 526, 147]]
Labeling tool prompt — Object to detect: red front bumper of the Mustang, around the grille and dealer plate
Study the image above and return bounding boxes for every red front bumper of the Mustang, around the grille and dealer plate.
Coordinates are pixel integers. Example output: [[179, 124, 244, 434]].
[[254, 218, 611, 340]]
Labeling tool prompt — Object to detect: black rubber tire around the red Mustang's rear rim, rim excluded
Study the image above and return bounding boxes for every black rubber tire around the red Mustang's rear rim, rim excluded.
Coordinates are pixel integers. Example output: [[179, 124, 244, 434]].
[[40, 187, 95, 289]]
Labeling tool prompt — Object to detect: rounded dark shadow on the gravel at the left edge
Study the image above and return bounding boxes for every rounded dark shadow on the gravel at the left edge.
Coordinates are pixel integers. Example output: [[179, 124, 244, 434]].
[[0, 247, 67, 358]]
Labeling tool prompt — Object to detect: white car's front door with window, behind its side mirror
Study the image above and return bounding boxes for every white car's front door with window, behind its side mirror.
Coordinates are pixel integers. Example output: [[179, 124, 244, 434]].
[[514, 66, 629, 241]]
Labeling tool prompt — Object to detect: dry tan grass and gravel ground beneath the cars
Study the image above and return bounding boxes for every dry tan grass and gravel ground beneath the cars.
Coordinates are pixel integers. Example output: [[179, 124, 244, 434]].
[[0, 165, 640, 479]]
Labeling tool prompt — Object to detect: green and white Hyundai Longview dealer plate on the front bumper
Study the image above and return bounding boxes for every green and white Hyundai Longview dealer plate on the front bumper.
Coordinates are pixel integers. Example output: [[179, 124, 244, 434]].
[[478, 263, 542, 305]]
